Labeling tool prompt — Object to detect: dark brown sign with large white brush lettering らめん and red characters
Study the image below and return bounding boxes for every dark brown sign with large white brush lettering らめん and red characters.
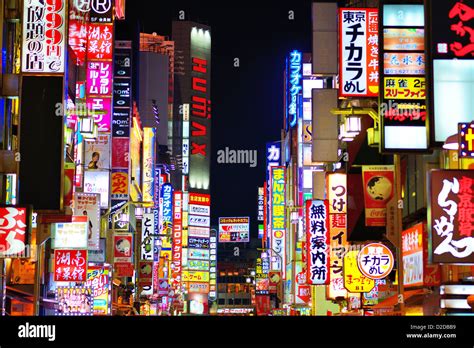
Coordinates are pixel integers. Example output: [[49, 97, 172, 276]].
[[428, 170, 474, 264]]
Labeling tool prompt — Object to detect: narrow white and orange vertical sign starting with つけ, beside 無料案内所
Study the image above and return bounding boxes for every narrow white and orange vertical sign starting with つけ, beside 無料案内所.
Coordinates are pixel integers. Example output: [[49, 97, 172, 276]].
[[327, 174, 347, 300]]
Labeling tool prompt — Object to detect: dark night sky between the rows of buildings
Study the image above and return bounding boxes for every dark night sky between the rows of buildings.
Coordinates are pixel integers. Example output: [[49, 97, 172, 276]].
[[122, 0, 312, 237]]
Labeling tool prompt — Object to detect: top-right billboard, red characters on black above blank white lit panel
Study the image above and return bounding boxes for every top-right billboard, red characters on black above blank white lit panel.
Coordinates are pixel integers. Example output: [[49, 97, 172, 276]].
[[425, 0, 474, 145]]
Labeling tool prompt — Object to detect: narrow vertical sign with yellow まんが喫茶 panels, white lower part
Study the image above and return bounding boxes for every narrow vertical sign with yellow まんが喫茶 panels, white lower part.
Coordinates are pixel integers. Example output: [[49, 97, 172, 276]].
[[270, 166, 286, 279]]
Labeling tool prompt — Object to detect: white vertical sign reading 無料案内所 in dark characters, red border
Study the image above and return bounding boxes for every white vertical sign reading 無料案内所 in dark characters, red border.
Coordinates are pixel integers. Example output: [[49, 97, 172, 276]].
[[306, 200, 330, 285]]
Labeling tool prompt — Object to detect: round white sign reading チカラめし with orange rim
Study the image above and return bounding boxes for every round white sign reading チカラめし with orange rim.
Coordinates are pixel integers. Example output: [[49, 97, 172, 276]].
[[357, 243, 393, 279]]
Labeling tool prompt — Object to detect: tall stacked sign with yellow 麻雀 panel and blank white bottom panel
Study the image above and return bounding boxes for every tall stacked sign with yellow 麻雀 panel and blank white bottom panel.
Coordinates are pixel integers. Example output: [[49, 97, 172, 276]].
[[379, 4, 429, 152]]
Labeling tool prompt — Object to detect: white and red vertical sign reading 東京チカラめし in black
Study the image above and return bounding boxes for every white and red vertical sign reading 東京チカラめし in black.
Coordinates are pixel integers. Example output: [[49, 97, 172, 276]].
[[339, 8, 379, 97]]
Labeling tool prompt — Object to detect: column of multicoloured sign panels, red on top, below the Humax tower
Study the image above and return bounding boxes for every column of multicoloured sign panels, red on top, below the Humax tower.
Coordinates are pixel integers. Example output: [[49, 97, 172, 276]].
[[187, 192, 211, 314]]
